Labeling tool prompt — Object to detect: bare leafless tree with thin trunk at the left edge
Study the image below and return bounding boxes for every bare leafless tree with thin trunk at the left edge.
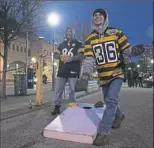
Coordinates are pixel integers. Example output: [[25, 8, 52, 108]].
[[0, 0, 44, 99]]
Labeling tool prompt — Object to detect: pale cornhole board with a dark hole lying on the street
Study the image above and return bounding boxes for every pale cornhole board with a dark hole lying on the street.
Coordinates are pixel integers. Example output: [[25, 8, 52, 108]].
[[43, 103, 105, 144]]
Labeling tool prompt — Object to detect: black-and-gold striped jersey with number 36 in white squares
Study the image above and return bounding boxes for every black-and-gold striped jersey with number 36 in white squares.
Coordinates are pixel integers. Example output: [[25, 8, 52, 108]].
[[84, 27, 130, 85]]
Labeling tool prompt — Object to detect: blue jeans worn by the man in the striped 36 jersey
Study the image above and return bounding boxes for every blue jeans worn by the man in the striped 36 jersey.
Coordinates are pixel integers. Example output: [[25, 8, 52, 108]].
[[98, 79, 123, 135]]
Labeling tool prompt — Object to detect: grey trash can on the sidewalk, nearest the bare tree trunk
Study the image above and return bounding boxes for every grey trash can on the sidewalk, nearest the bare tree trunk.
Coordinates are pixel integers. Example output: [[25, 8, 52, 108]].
[[14, 74, 27, 96]]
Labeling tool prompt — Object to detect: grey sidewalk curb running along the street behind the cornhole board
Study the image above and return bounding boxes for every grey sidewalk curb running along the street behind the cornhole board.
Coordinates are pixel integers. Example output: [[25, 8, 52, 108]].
[[0, 90, 100, 121]]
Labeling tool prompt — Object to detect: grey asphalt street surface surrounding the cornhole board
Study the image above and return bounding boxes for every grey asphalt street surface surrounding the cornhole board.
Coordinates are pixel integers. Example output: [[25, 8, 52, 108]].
[[1, 88, 153, 148]]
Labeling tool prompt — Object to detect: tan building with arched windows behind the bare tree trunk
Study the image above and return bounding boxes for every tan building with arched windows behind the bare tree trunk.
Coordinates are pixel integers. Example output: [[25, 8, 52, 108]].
[[0, 38, 53, 81]]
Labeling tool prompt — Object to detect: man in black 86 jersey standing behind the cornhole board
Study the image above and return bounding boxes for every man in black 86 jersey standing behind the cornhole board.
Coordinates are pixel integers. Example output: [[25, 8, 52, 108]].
[[52, 27, 84, 115]]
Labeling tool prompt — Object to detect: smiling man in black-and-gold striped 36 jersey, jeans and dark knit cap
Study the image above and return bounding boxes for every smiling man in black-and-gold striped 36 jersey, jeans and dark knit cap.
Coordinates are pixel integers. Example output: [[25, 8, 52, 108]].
[[78, 8, 144, 146]]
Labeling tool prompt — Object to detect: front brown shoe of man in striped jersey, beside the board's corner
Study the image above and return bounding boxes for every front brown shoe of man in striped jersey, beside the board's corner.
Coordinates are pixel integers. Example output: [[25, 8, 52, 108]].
[[93, 133, 110, 146]]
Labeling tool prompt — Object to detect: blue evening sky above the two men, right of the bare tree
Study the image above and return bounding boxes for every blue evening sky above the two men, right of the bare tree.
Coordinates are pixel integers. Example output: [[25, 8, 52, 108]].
[[38, 0, 153, 61]]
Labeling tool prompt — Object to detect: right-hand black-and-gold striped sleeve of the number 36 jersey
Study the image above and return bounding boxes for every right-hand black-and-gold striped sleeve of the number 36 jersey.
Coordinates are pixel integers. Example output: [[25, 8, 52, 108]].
[[118, 30, 131, 51]]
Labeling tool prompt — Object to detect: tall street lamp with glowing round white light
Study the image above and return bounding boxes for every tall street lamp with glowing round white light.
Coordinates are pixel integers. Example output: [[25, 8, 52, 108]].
[[48, 12, 60, 91]]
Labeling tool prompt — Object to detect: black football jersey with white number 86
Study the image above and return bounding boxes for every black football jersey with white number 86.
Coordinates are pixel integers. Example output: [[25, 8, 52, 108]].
[[57, 39, 84, 78]]
